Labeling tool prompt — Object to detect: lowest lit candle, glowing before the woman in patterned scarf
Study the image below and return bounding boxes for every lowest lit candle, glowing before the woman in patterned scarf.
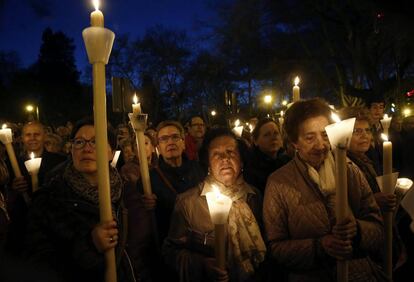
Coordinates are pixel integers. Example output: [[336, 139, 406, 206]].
[[206, 186, 232, 269]]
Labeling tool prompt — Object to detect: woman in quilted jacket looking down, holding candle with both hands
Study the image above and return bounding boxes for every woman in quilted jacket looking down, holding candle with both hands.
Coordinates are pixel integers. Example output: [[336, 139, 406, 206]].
[[263, 99, 383, 281]]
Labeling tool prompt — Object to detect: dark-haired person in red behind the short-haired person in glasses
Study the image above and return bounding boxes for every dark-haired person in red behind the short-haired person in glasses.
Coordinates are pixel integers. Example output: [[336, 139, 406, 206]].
[[185, 116, 206, 160]]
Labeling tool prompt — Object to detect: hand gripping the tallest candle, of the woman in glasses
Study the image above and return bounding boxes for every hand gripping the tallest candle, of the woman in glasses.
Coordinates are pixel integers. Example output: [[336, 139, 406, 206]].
[[91, 220, 118, 253]]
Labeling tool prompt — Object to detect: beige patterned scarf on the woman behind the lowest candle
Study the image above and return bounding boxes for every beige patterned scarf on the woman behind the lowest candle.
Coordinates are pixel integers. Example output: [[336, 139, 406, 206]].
[[202, 176, 266, 281]]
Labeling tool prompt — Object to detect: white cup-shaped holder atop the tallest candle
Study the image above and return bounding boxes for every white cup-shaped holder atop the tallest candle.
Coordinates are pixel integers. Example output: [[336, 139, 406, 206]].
[[82, 27, 115, 64]]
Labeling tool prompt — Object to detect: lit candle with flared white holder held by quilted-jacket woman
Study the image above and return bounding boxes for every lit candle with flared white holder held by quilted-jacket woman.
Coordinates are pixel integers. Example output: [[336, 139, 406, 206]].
[[325, 114, 355, 281]]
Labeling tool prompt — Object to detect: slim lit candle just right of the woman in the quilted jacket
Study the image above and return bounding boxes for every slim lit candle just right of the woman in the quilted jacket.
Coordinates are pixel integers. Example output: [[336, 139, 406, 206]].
[[381, 133, 394, 281]]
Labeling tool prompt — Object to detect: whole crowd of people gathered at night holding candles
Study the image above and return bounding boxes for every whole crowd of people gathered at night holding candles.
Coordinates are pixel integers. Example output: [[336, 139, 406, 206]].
[[0, 99, 414, 281]]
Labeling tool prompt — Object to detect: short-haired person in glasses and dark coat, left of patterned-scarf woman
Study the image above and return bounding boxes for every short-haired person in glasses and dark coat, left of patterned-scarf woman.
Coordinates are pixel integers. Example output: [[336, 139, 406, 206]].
[[138, 120, 204, 280]]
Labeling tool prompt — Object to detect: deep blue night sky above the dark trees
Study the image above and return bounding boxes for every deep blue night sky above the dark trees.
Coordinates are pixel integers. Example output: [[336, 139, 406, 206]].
[[0, 0, 212, 70]]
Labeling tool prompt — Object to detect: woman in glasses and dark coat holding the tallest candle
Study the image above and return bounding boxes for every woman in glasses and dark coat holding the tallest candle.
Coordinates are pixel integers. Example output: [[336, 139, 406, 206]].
[[26, 117, 132, 281]]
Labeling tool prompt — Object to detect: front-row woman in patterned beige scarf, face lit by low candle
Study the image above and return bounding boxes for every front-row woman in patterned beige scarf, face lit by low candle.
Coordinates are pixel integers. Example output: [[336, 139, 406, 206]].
[[163, 129, 266, 281]]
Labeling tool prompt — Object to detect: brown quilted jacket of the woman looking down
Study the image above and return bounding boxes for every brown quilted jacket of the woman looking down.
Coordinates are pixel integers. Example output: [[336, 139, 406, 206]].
[[263, 157, 383, 281]]
